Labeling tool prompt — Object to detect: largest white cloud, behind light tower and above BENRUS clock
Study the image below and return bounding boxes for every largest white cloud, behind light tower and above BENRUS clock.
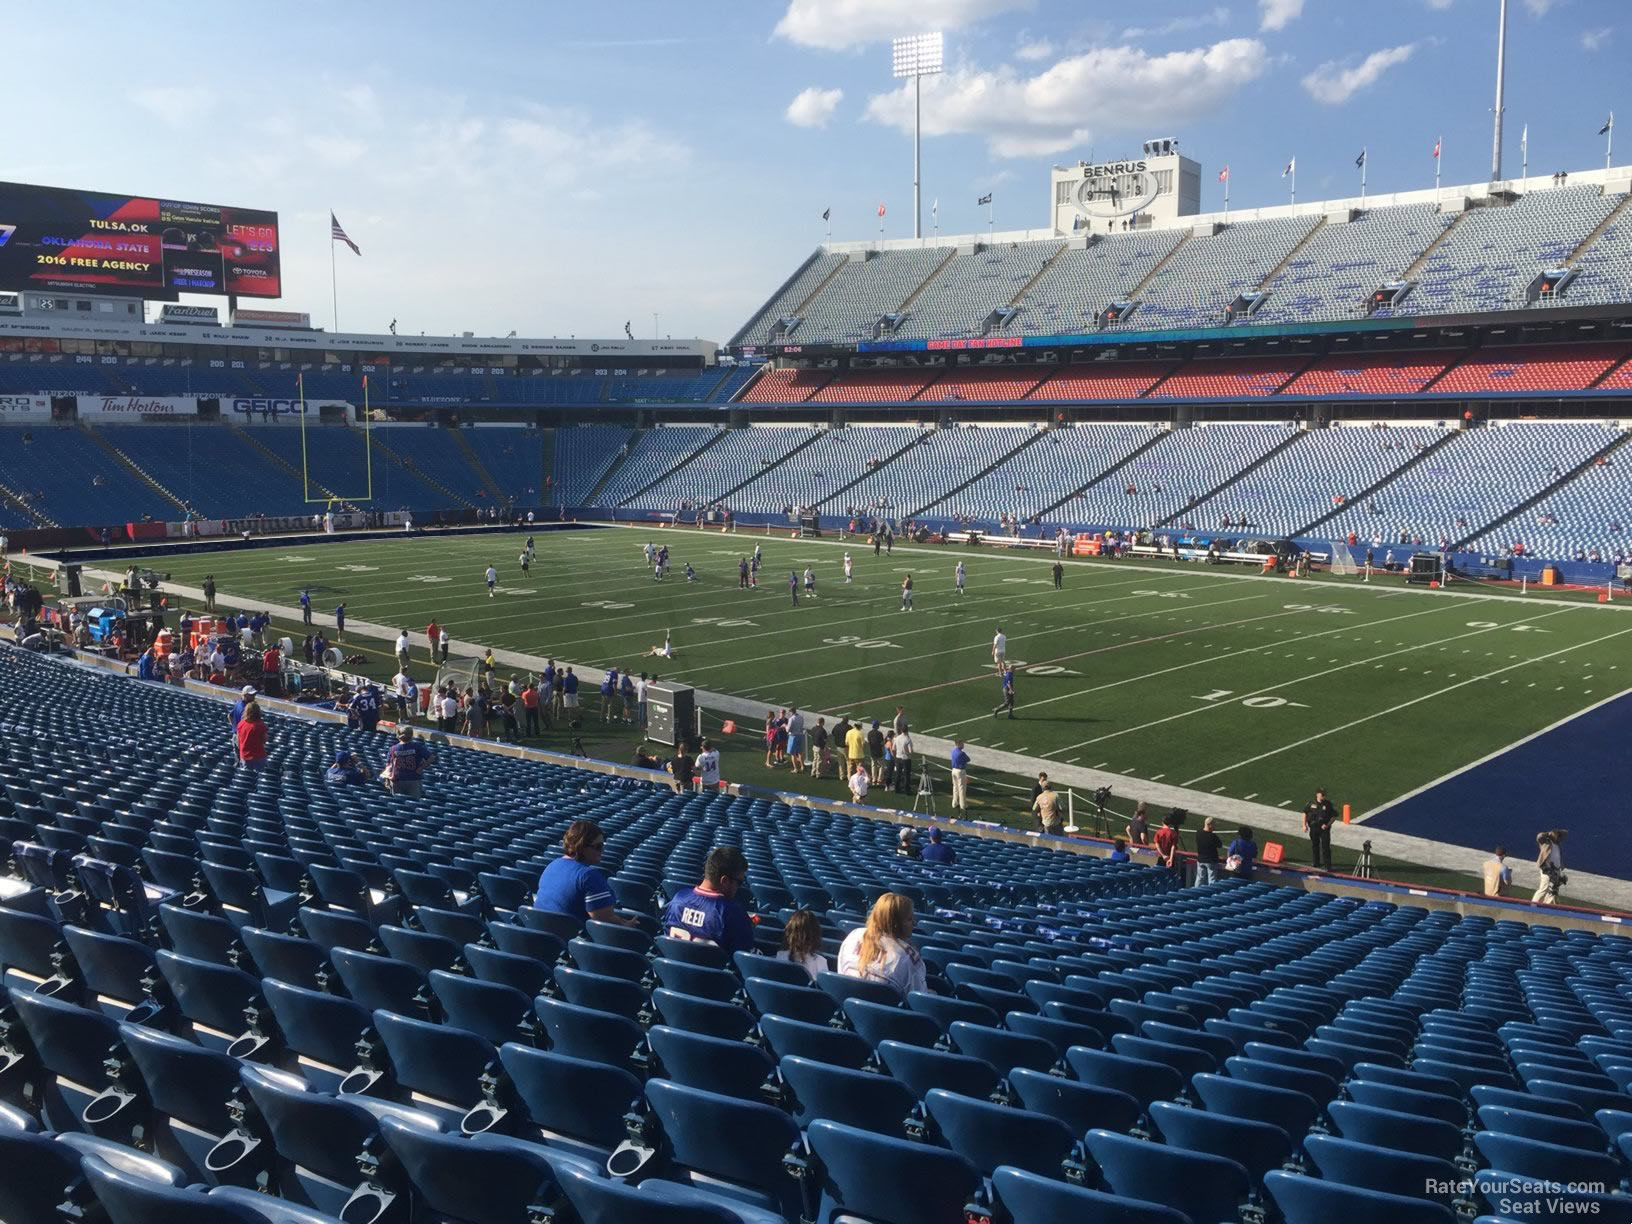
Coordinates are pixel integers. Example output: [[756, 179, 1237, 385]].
[[867, 38, 1270, 157]]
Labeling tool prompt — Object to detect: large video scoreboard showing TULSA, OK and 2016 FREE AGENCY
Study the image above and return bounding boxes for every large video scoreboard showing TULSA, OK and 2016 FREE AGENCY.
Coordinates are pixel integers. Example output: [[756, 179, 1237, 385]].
[[0, 183, 282, 300]]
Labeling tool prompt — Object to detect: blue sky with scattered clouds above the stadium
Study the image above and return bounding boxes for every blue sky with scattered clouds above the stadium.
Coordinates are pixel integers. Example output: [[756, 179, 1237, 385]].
[[0, 0, 1632, 341]]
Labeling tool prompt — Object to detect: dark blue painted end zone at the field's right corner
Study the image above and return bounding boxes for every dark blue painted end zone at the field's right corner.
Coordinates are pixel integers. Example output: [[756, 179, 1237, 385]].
[[1364, 694, 1632, 880]]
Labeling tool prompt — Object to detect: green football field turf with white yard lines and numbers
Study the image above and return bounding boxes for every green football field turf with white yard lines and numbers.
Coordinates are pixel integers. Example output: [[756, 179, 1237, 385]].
[[153, 527, 1632, 829]]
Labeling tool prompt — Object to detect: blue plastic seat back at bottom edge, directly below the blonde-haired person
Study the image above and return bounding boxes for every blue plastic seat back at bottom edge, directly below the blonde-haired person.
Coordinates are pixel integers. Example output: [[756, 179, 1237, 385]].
[[806, 1120, 979, 1224]]
